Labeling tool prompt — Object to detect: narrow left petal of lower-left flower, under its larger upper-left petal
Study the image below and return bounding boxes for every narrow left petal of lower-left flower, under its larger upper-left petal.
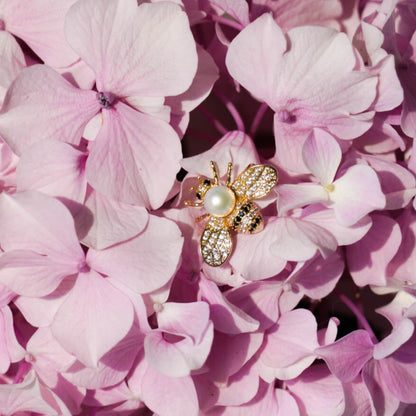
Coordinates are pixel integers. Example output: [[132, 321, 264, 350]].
[[0, 250, 78, 297]]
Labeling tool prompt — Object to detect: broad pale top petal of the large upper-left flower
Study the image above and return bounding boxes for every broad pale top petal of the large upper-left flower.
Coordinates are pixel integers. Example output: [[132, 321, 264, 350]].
[[65, 0, 197, 97]]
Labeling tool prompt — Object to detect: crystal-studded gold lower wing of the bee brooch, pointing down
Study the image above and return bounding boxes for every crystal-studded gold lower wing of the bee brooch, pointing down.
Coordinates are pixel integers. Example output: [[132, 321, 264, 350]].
[[201, 217, 233, 267]]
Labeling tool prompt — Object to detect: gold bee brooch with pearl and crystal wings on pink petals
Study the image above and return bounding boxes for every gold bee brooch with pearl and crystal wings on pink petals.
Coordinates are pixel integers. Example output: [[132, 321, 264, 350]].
[[185, 161, 278, 267]]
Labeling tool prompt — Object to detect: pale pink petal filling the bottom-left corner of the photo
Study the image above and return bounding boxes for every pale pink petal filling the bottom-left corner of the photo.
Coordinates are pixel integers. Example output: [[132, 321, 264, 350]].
[[0, 371, 59, 416]]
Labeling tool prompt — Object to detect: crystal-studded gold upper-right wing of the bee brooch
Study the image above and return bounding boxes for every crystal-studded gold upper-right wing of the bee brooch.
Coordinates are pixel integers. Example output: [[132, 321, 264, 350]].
[[231, 165, 277, 200]]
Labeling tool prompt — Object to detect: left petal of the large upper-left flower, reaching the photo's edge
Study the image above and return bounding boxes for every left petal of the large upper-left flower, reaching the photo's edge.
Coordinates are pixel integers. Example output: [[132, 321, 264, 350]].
[[0, 65, 100, 155]]
